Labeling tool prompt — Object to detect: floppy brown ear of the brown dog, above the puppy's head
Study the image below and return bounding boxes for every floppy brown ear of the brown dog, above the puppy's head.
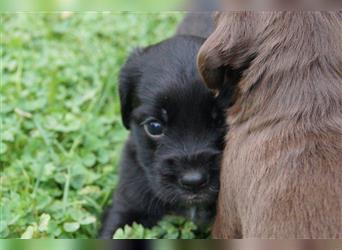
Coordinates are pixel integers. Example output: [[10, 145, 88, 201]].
[[197, 11, 257, 90]]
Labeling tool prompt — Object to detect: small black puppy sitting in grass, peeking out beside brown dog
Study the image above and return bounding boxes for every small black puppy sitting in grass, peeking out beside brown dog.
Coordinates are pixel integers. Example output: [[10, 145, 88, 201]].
[[100, 35, 226, 238]]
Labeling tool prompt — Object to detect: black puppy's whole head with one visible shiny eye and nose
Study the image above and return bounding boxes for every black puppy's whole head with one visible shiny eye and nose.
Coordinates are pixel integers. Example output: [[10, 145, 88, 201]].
[[120, 37, 225, 206]]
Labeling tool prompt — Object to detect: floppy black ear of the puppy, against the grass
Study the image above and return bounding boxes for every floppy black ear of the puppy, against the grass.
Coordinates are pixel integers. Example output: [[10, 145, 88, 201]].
[[119, 48, 143, 129]]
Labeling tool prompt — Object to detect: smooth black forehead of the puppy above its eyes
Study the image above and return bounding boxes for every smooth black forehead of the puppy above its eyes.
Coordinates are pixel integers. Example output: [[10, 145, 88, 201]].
[[137, 37, 213, 121]]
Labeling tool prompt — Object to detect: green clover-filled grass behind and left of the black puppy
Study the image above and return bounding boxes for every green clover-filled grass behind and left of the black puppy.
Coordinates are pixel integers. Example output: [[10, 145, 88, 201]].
[[0, 13, 187, 238]]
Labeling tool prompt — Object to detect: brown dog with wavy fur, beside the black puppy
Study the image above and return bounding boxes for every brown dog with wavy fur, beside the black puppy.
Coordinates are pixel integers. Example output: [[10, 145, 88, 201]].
[[198, 12, 342, 238]]
